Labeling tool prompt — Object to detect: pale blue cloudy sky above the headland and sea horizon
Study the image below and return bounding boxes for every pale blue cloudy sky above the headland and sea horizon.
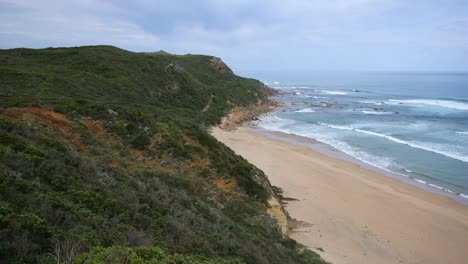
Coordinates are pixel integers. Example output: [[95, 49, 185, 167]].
[[0, 0, 468, 72]]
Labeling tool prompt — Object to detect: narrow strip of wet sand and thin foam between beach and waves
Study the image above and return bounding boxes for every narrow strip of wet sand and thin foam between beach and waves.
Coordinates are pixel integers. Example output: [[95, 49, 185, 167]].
[[252, 124, 468, 206]]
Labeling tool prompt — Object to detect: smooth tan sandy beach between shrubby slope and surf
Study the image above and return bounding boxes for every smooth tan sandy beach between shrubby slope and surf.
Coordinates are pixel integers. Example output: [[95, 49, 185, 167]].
[[212, 126, 468, 264]]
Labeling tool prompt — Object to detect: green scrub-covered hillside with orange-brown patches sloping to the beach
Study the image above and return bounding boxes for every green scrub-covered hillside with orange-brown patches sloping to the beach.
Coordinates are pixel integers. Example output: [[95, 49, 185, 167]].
[[0, 46, 323, 263]]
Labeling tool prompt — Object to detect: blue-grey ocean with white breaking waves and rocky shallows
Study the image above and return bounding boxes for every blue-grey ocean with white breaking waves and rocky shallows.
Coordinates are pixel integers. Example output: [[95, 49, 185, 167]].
[[245, 72, 468, 199]]
